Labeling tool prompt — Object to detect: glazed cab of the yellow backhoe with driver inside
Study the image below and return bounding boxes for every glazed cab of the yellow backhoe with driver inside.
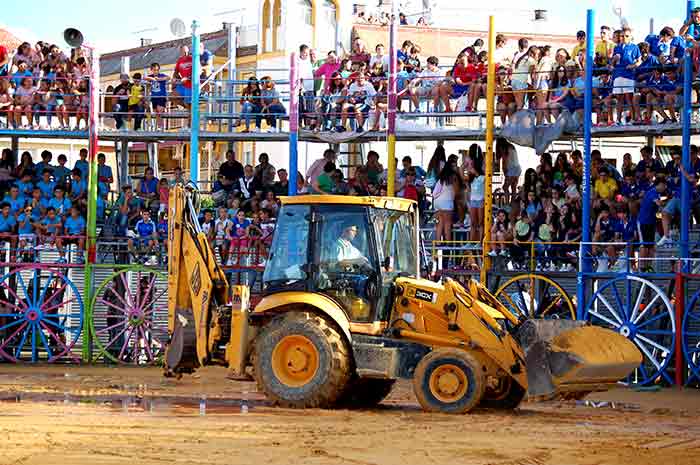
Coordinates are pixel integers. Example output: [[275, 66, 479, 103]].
[[263, 195, 418, 323]]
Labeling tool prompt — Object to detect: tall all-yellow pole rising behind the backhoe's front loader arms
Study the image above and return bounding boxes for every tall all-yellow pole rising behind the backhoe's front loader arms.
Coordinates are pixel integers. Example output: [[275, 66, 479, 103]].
[[481, 16, 496, 285]]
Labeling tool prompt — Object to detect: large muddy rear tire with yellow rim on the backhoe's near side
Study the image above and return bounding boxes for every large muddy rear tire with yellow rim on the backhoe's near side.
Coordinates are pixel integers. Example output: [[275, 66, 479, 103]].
[[253, 312, 352, 408]]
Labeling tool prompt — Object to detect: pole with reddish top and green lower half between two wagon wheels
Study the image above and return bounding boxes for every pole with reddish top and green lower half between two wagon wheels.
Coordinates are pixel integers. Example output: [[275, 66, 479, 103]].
[[83, 48, 99, 362]]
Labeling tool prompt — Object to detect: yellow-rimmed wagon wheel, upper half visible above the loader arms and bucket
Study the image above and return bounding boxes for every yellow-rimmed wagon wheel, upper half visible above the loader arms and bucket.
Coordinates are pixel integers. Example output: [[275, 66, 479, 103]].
[[494, 274, 576, 320]]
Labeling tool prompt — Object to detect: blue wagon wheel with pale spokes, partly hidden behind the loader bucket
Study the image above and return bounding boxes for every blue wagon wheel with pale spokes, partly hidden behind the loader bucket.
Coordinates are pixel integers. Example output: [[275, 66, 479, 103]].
[[584, 275, 676, 385]]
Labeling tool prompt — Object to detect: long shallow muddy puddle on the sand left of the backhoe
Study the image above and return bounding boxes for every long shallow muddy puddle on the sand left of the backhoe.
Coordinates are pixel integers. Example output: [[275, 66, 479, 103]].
[[0, 392, 266, 416]]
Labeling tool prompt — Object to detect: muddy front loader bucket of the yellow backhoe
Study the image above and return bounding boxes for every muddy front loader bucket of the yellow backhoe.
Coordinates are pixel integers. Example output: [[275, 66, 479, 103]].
[[517, 320, 642, 398]]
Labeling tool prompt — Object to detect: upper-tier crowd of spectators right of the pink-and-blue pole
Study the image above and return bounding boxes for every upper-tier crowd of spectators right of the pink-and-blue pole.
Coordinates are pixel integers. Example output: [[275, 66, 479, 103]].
[[282, 9, 700, 132]]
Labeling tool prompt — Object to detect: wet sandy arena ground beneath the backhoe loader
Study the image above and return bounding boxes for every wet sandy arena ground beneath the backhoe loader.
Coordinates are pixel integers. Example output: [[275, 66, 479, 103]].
[[0, 365, 700, 465]]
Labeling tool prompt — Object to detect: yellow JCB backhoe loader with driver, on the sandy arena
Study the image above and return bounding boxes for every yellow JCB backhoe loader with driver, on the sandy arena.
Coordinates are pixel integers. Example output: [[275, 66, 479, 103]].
[[165, 186, 642, 413]]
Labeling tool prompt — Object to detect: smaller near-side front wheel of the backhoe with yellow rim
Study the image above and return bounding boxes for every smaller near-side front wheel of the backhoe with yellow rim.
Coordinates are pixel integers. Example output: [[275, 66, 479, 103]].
[[413, 348, 486, 413]]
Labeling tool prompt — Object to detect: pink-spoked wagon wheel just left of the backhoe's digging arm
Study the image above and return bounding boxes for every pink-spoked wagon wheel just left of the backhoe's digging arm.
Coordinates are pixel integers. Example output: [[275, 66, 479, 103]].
[[91, 266, 168, 365]]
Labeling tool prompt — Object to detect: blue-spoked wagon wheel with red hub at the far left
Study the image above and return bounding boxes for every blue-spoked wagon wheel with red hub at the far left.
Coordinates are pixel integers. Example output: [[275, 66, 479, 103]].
[[0, 266, 84, 362]]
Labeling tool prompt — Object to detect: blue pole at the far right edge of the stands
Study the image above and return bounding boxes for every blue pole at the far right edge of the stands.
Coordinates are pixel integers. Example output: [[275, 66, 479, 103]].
[[681, 0, 695, 273]]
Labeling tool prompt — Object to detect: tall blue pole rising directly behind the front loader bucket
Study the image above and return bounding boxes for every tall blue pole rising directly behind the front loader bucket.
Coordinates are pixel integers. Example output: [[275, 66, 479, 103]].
[[576, 10, 595, 319]]
